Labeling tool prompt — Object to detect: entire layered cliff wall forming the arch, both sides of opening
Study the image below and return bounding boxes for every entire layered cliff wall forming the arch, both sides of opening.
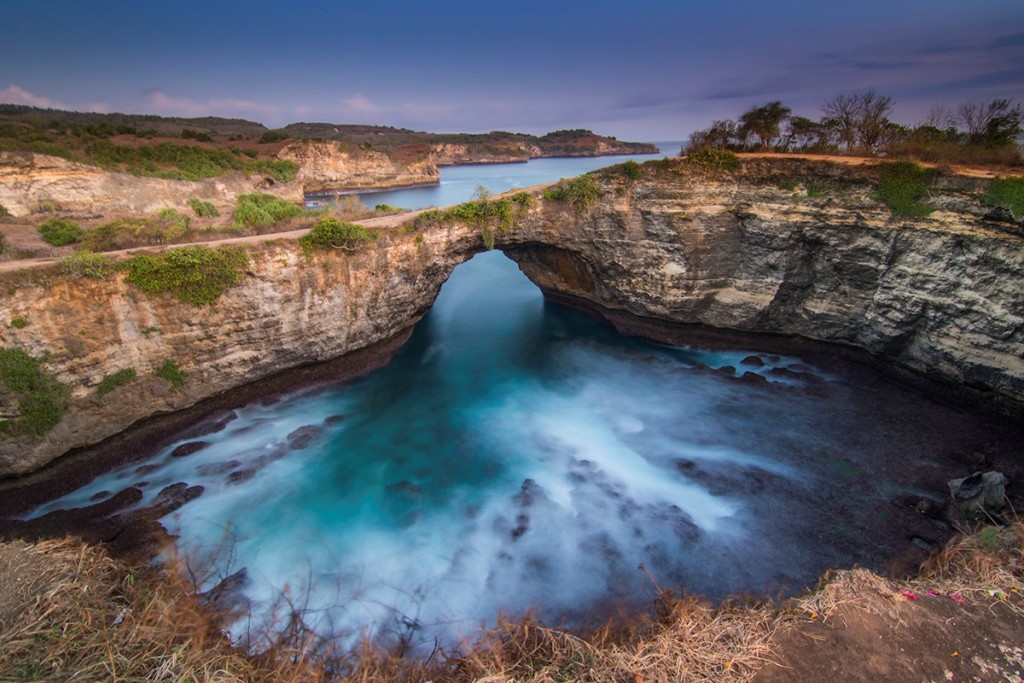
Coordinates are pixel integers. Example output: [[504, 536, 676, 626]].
[[0, 155, 1024, 475]]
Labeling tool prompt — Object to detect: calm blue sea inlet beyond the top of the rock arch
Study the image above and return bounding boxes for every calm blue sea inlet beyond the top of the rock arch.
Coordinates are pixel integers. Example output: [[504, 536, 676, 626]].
[[307, 141, 682, 209]]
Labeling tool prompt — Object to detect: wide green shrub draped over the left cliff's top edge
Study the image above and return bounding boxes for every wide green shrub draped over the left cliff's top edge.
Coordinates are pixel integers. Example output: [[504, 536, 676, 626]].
[[121, 246, 249, 306]]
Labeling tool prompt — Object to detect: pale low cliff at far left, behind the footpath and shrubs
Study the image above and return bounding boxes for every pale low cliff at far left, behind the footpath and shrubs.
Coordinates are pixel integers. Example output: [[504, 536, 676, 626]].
[[0, 152, 302, 216]]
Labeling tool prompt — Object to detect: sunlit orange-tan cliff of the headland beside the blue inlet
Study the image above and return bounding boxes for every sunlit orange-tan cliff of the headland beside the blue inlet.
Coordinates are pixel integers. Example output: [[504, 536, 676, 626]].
[[278, 142, 440, 194]]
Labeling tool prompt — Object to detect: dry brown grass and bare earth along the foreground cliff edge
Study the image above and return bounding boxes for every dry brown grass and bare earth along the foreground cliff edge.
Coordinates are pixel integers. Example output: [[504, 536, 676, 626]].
[[0, 521, 1024, 683]]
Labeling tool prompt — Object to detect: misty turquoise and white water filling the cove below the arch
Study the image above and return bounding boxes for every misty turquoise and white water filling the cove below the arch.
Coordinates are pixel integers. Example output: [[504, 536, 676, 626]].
[[33, 252, 1015, 644]]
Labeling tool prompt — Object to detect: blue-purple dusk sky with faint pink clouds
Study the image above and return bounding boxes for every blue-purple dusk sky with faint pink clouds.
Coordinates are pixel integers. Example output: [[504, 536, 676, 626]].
[[0, 0, 1024, 140]]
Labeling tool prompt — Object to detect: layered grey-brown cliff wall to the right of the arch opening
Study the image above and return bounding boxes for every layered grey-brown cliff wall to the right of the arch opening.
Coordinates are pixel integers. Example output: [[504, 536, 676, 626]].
[[499, 160, 1024, 401]]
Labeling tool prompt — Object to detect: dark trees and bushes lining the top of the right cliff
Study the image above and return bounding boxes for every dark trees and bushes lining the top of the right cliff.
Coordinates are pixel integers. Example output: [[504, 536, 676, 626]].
[[687, 90, 1024, 164]]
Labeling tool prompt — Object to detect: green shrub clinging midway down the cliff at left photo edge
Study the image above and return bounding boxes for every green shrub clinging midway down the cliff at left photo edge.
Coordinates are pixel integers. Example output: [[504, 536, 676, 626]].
[[0, 348, 68, 436]]
